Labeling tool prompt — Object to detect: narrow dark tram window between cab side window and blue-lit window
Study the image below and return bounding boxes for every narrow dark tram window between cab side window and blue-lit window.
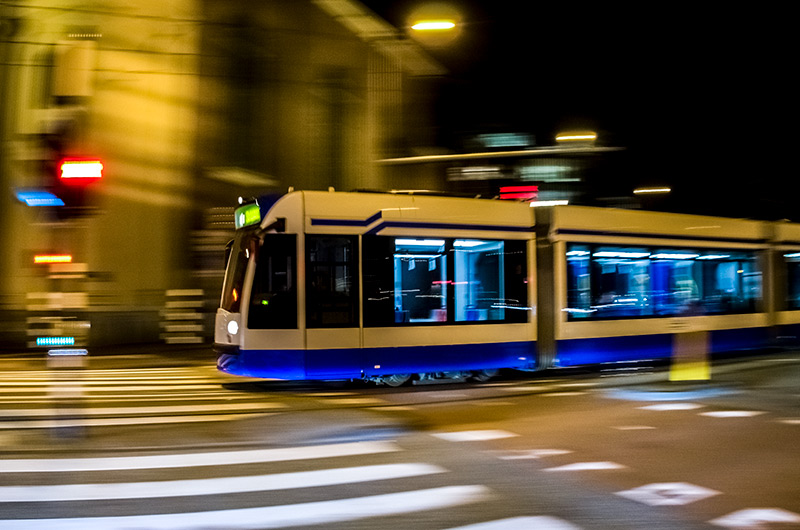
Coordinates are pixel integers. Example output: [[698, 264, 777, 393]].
[[306, 235, 358, 328]]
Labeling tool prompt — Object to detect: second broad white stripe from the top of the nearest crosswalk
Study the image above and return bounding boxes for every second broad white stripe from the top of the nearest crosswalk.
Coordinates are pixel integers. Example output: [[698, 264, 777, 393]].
[[0, 463, 447, 503]]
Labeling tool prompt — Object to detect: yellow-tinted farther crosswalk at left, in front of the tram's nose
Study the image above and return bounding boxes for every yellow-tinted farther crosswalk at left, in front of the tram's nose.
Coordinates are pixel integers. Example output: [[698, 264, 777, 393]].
[[0, 367, 286, 431]]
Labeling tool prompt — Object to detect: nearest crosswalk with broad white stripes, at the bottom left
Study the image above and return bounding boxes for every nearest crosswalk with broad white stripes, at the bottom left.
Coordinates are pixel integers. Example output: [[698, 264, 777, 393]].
[[0, 441, 579, 530]]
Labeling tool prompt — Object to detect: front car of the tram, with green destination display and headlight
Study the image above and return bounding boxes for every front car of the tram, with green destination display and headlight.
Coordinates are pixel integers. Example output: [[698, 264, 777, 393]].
[[215, 191, 536, 385]]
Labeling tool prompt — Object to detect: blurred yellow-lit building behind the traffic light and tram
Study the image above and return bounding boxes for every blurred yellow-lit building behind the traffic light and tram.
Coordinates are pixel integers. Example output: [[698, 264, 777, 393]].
[[0, 0, 639, 349]]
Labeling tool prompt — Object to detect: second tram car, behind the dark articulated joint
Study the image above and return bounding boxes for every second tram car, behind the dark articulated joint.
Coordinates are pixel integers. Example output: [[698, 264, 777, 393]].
[[537, 206, 773, 366]]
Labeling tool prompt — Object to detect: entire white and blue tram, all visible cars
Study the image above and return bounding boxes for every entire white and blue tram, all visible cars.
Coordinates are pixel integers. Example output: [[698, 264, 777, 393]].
[[214, 191, 800, 385]]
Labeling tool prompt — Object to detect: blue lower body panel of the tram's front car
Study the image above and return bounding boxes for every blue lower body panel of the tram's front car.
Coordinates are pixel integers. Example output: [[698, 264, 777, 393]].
[[217, 342, 536, 380]]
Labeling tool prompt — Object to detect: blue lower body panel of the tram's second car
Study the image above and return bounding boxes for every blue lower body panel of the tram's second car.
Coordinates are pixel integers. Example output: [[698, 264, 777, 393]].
[[555, 328, 769, 367]]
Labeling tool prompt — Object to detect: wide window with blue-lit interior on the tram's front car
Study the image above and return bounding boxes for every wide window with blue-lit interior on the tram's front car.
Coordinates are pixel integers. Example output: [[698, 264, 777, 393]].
[[362, 236, 528, 326]]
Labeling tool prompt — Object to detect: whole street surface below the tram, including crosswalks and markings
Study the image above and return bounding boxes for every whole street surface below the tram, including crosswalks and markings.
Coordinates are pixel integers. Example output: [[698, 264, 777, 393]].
[[0, 351, 800, 530]]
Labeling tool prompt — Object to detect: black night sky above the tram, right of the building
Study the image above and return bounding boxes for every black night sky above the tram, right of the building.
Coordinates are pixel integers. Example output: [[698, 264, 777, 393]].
[[363, 0, 800, 221]]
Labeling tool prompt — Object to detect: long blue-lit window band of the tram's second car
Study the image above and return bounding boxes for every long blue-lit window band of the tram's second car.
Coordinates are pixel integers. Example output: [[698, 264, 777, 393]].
[[567, 244, 762, 320]]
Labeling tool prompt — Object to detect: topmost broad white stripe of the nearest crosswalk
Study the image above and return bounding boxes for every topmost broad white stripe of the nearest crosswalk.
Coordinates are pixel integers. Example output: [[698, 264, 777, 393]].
[[0, 441, 400, 470]]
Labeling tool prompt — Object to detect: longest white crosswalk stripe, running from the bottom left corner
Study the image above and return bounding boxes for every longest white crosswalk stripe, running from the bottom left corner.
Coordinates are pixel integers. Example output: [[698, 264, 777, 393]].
[[0, 485, 493, 530]]
